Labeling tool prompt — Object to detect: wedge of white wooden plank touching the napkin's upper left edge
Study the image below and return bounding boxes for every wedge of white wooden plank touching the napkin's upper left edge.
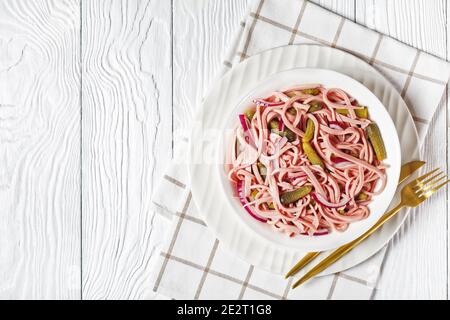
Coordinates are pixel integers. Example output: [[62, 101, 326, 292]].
[[173, 0, 250, 153]]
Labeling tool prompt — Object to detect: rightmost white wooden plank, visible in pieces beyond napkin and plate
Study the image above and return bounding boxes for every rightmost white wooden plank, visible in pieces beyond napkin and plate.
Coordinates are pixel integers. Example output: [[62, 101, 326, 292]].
[[356, 0, 448, 299]]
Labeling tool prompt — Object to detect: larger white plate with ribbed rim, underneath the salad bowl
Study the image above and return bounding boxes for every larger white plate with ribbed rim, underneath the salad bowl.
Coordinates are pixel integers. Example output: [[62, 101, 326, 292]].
[[189, 45, 420, 274]]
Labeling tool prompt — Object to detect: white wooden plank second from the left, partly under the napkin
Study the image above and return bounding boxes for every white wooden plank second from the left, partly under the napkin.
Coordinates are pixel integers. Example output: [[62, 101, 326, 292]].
[[82, 0, 172, 299]]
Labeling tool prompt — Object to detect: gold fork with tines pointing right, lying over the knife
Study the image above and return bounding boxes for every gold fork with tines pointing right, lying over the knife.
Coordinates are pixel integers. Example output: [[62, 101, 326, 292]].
[[292, 169, 450, 288]]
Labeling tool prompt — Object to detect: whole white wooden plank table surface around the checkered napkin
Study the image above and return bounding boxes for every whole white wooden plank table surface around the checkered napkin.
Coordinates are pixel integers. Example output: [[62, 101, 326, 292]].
[[0, 0, 450, 299]]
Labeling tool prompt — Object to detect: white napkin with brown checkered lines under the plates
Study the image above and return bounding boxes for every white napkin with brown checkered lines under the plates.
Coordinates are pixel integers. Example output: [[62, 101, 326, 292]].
[[152, 0, 450, 299]]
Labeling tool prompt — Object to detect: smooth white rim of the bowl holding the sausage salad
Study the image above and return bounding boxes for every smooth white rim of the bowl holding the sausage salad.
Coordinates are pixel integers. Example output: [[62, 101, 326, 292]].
[[218, 68, 401, 251]]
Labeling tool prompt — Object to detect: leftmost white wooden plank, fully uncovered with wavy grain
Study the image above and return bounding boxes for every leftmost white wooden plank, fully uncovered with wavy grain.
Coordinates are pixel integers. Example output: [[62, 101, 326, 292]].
[[0, 0, 81, 299]]
